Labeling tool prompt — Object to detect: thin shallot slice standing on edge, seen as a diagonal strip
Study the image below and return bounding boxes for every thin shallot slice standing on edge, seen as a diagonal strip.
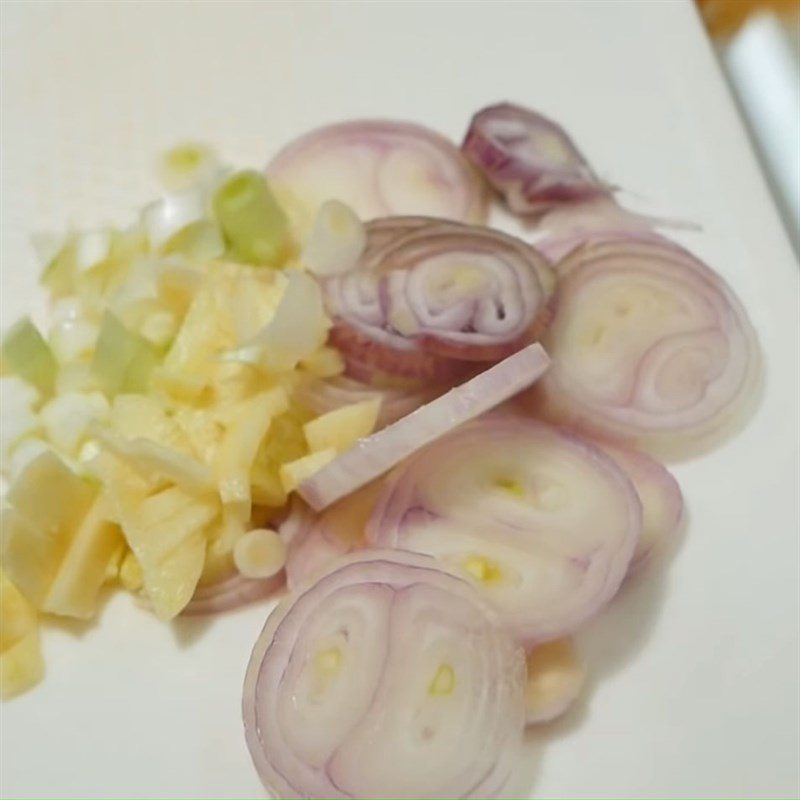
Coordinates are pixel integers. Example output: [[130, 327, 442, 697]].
[[299, 344, 550, 511]]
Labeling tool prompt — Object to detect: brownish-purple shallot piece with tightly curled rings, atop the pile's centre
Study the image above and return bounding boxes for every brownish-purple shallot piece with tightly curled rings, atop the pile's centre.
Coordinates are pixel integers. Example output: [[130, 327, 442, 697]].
[[325, 217, 554, 380]]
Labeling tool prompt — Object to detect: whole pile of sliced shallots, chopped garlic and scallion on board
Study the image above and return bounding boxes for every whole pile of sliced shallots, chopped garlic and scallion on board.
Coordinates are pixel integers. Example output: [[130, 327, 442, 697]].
[[0, 104, 760, 798]]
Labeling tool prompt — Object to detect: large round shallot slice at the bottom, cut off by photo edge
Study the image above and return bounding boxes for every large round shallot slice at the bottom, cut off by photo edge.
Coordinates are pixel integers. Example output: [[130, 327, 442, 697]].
[[247, 551, 525, 798]]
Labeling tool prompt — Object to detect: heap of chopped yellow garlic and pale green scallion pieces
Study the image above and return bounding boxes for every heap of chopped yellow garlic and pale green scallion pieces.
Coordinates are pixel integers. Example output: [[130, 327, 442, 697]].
[[0, 145, 362, 660]]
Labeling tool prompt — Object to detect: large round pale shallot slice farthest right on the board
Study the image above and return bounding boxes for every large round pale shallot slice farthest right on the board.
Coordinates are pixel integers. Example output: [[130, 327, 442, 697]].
[[532, 236, 761, 457]]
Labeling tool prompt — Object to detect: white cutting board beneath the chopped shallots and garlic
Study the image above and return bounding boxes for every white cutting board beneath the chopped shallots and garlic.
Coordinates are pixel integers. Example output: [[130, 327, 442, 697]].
[[0, 0, 800, 798]]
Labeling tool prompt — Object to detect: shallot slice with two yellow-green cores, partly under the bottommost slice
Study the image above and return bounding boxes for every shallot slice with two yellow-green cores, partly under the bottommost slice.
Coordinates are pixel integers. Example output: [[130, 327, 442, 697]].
[[367, 414, 641, 645]]
